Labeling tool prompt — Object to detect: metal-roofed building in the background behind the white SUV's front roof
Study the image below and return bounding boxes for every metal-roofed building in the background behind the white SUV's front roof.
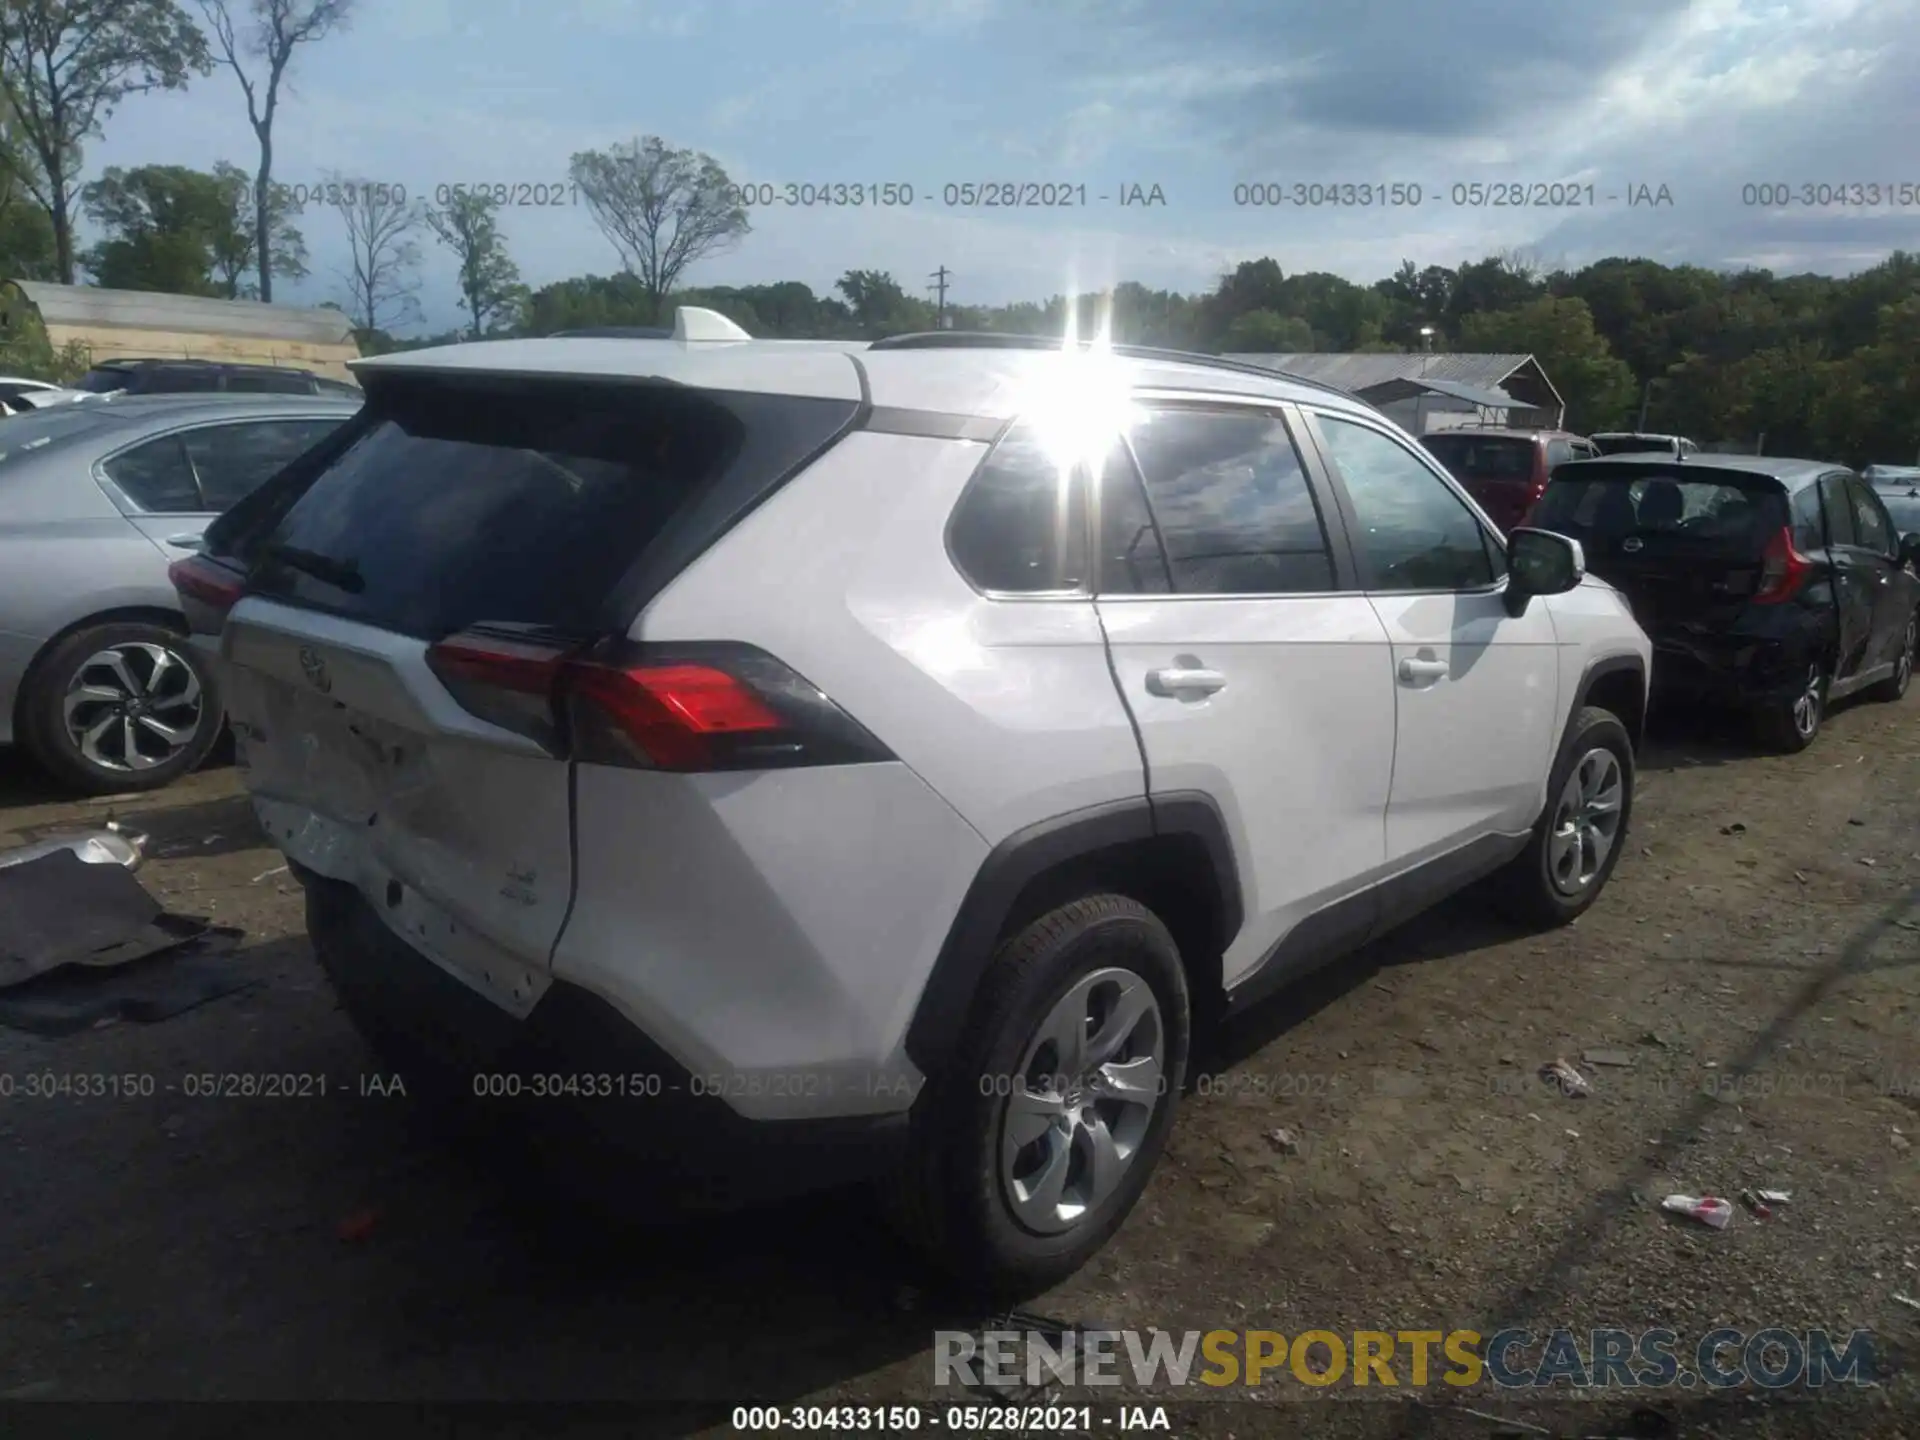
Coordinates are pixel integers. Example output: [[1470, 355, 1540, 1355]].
[[1225, 353, 1567, 434]]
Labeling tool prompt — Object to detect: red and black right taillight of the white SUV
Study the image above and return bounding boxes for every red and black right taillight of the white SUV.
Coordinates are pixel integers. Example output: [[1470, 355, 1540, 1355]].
[[426, 628, 891, 772]]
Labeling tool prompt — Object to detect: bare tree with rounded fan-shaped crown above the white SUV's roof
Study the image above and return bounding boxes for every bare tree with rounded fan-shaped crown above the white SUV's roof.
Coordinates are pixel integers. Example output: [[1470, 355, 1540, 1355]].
[[570, 134, 753, 319]]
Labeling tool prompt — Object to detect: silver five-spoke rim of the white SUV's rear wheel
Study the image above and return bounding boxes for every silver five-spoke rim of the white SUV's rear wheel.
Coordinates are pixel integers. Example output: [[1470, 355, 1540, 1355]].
[[998, 966, 1167, 1235]]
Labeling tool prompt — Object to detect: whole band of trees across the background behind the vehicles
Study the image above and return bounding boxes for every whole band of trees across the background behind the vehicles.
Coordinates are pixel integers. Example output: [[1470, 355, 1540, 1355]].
[[0, 0, 1920, 465]]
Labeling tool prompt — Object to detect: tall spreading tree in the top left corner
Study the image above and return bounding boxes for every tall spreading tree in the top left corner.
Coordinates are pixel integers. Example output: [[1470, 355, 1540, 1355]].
[[0, 0, 211, 284]]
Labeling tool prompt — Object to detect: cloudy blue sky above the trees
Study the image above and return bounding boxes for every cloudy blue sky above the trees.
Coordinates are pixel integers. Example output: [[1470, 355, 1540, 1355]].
[[90, 0, 1920, 328]]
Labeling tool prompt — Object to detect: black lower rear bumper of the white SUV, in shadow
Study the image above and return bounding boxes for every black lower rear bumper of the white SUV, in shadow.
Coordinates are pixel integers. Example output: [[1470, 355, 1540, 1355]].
[[296, 868, 906, 1212]]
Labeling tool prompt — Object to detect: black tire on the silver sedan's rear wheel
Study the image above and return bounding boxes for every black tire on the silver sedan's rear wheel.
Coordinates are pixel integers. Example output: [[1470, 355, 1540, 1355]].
[[19, 620, 225, 795]]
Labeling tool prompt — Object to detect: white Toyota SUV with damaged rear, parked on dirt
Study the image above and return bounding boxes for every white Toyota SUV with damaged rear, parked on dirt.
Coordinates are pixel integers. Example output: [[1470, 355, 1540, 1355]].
[[175, 317, 1649, 1288]]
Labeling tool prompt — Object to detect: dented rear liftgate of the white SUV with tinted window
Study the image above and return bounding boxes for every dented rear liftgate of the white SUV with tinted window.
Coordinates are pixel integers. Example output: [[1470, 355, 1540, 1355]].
[[209, 372, 856, 1014]]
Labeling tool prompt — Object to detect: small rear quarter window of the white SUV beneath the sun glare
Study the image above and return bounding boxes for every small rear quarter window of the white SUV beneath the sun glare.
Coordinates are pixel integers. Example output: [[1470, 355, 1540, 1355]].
[[947, 420, 1087, 595]]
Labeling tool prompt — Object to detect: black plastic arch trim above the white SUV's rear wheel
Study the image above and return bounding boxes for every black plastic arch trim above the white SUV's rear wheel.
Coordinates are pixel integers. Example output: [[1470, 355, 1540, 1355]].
[[906, 791, 1244, 1075]]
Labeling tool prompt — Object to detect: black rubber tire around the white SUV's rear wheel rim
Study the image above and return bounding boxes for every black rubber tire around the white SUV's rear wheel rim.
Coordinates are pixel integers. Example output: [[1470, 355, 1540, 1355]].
[[889, 895, 1190, 1300]]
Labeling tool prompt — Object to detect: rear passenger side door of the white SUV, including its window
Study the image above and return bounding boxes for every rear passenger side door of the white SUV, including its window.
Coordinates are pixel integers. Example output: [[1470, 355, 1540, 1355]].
[[1096, 399, 1394, 985]]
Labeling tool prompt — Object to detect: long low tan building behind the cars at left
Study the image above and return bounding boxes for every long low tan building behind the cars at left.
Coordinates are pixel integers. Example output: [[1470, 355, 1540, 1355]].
[[0, 280, 359, 380]]
